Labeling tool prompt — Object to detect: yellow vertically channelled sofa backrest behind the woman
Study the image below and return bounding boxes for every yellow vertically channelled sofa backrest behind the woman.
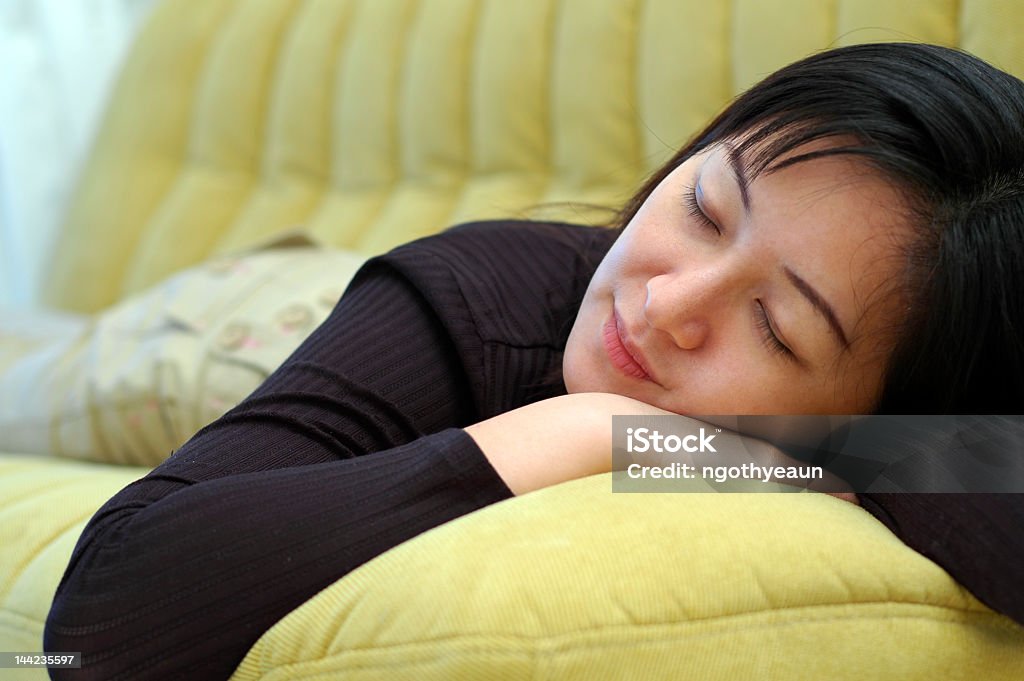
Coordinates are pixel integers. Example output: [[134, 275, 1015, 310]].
[[44, 0, 1024, 311]]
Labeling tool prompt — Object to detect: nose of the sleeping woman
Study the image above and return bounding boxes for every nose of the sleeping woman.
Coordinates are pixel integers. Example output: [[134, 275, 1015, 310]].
[[643, 269, 736, 350]]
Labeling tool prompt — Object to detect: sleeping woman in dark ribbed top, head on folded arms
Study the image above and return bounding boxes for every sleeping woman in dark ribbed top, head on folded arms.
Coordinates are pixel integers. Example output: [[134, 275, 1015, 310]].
[[45, 44, 1024, 681]]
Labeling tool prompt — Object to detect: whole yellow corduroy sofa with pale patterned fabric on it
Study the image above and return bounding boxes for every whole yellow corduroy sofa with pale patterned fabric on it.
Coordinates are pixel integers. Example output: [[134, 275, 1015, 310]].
[[6, 0, 1024, 681]]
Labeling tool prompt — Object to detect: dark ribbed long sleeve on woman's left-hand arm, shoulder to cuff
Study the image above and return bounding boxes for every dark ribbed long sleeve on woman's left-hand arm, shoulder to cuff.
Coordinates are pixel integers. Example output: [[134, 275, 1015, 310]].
[[44, 246, 511, 681]]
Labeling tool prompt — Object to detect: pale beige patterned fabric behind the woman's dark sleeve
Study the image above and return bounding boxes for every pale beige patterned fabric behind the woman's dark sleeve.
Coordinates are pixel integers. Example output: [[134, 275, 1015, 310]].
[[0, 232, 365, 466]]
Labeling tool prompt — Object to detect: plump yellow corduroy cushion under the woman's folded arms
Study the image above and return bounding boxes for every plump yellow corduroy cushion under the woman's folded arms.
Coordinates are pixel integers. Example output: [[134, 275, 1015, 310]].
[[232, 475, 1024, 681]]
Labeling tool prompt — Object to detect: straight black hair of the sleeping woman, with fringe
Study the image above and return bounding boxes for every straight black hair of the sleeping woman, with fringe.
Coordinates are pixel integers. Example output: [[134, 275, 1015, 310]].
[[613, 43, 1024, 414]]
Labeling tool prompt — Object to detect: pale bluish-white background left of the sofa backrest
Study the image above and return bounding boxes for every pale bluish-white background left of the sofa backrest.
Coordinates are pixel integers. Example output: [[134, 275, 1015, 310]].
[[0, 0, 158, 308]]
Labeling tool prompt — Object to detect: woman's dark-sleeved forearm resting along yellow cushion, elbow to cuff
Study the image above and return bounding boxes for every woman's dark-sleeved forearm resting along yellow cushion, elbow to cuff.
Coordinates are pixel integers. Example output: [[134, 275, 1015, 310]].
[[44, 429, 511, 681]]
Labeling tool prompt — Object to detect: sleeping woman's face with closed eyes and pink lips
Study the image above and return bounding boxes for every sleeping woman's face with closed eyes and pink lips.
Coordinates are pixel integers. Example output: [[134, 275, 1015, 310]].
[[563, 143, 910, 416]]
